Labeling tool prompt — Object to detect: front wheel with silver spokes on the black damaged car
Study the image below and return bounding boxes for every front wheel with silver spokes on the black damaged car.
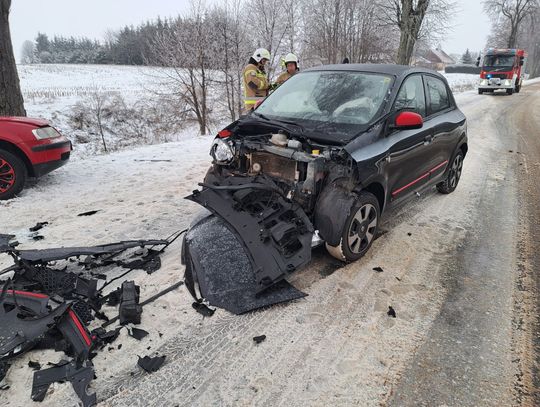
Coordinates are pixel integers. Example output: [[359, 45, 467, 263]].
[[326, 192, 381, 262]]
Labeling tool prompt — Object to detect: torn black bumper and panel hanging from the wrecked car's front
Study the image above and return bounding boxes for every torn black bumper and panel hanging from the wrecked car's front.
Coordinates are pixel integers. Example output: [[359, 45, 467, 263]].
[[184, 179, 313, 314]]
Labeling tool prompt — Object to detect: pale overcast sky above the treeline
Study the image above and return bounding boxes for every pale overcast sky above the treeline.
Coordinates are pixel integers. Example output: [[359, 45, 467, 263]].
[[10, 0, 489, 59]]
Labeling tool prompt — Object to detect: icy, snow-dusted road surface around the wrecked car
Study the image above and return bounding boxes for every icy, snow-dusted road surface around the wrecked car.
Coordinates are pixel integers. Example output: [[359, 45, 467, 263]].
[[0, 80, 540, 407]]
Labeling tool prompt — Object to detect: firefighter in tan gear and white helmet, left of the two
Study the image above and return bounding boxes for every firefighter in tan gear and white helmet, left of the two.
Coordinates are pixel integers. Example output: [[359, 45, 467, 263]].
[[243, 48, 270, 114]]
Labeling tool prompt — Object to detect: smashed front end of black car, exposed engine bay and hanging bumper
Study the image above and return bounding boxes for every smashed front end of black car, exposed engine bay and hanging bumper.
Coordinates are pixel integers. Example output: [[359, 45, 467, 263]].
[[183, 121, 362, 313]]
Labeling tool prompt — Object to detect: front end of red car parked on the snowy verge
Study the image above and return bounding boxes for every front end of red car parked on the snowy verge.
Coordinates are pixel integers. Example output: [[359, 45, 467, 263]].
[[0, 117, 72, 200]]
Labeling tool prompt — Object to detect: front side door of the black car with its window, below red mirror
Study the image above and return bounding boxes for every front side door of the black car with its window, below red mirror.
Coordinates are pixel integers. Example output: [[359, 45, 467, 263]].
[[385, 74, 433, 201]]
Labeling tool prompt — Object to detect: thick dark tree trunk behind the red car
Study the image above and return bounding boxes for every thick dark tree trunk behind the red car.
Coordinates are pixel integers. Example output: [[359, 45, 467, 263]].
[[0, 0, 26, 116]]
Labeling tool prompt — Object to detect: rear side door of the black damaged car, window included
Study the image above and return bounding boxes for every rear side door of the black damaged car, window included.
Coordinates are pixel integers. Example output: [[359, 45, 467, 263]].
[[424, 74, 460, 180]]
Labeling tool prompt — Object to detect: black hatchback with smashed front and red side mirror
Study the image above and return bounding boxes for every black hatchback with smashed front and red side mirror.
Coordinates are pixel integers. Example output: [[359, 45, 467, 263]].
[[184, 64, 468, 312]]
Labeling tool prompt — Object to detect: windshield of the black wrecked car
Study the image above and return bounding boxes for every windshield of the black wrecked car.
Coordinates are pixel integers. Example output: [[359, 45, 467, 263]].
[[256, 71, 392, 134]]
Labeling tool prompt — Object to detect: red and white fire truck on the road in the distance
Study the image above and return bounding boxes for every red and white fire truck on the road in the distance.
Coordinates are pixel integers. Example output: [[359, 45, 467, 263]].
[[476, 48, 527, 95]]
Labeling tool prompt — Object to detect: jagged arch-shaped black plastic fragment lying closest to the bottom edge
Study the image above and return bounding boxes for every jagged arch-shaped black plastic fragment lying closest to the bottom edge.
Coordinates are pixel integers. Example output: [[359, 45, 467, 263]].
[[32, 361, 97, 407]]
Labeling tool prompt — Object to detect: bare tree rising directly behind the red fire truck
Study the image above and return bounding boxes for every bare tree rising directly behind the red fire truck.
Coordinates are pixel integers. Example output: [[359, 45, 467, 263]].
[[484, 0, 540, 48]]
